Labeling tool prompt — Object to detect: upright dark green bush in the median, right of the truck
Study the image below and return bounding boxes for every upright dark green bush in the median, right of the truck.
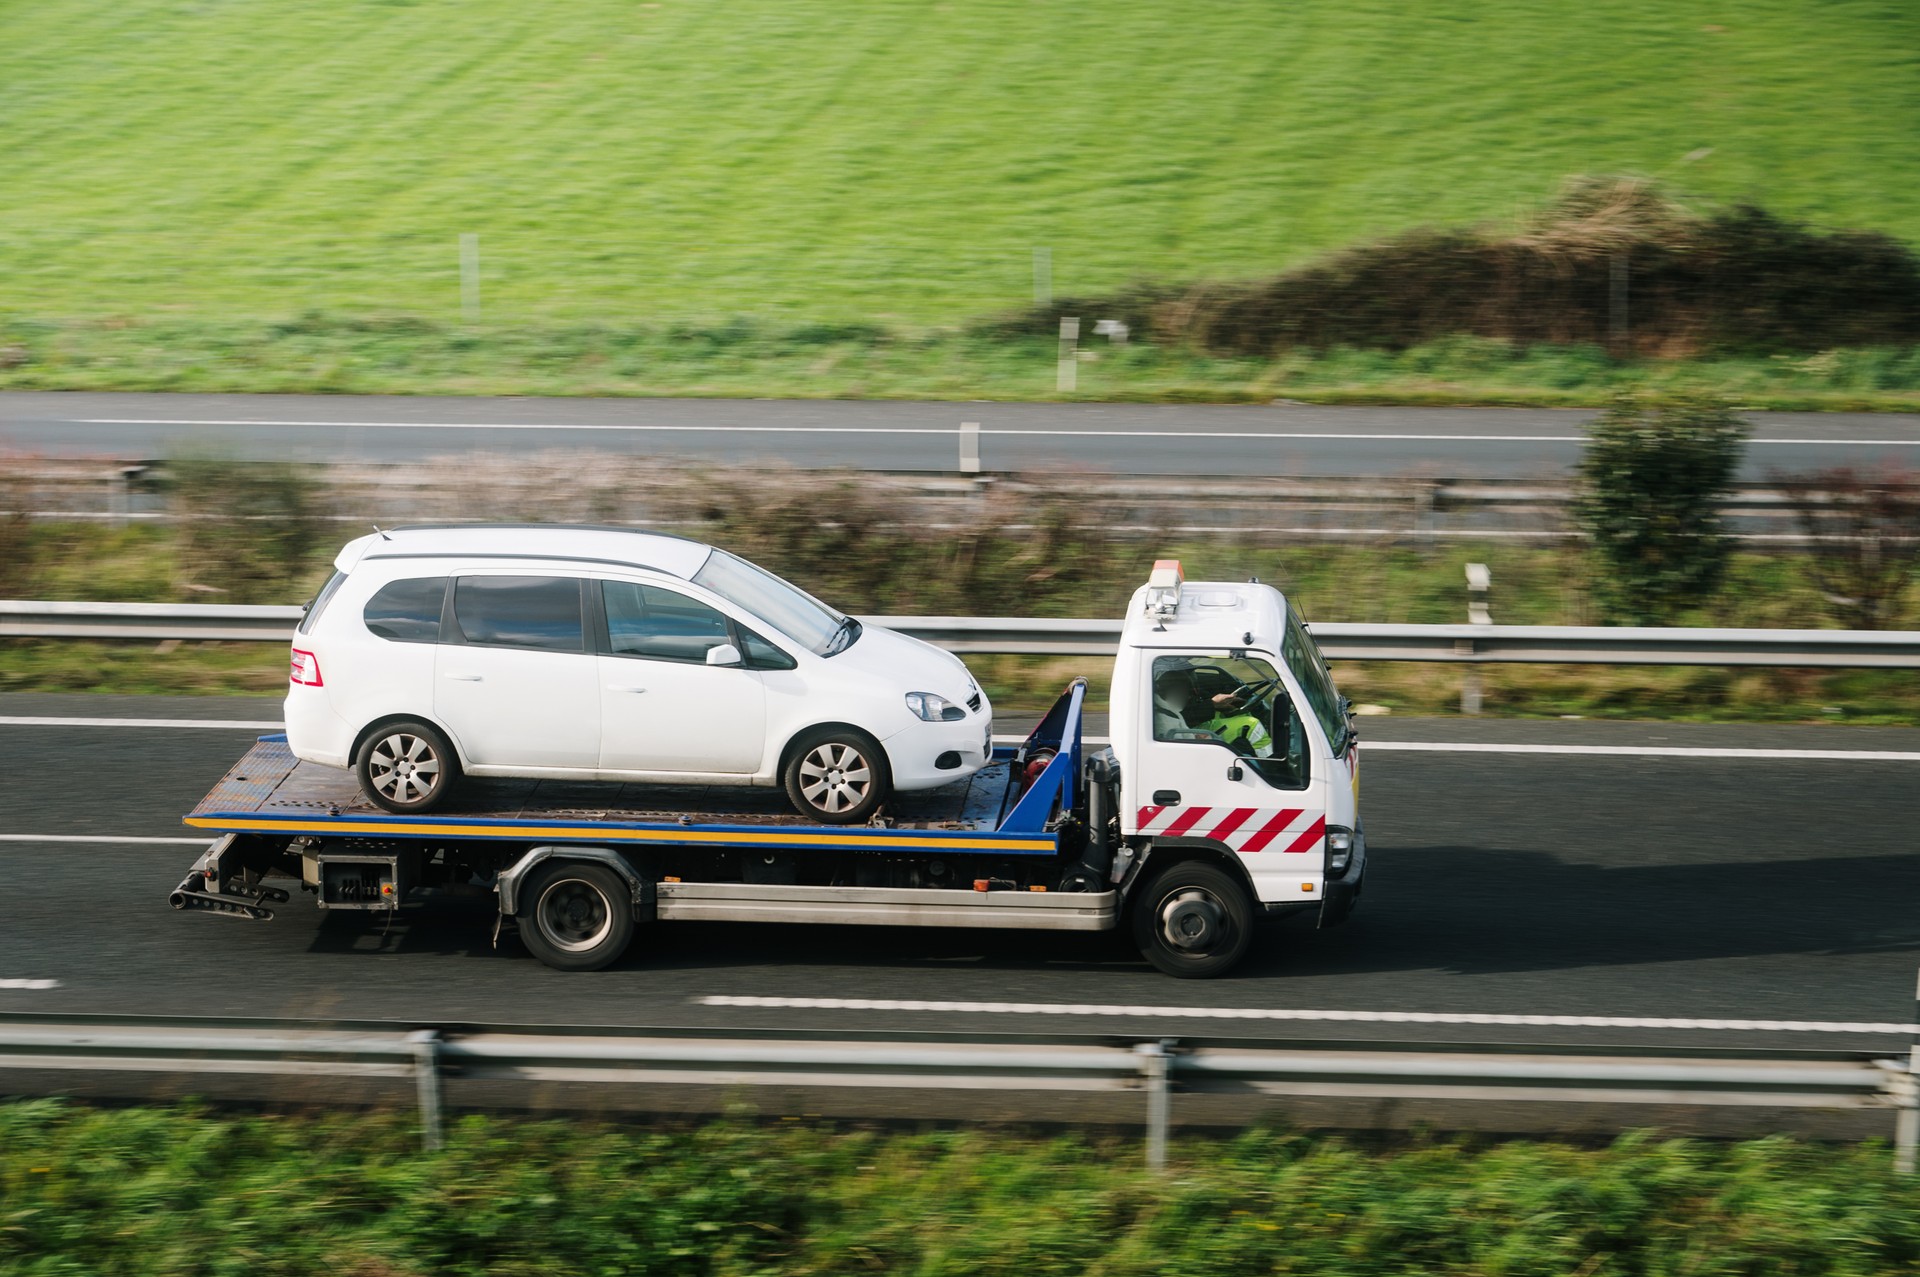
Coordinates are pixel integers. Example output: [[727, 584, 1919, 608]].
[[1574, 396, 1747, 624]]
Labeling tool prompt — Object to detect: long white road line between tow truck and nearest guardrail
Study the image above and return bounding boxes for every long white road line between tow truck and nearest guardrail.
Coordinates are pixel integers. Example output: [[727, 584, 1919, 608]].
[[695, 995, 1920, 1037]]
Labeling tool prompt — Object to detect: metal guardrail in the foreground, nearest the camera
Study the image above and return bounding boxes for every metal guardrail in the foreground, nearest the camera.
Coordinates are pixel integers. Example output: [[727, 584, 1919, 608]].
[[0, 1016, 1920, 1171]]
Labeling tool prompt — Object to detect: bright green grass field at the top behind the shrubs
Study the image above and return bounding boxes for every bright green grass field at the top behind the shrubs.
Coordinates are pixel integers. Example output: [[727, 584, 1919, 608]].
[[0, 0, 1920, 334]]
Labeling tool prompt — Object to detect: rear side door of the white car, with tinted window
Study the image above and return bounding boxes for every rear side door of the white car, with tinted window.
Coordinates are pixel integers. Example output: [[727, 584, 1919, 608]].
[[434, 572, 601, 772]]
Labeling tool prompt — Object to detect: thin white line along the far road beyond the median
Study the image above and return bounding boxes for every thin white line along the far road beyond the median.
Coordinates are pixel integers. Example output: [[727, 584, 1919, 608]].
[[69, 417, 1920, 447]]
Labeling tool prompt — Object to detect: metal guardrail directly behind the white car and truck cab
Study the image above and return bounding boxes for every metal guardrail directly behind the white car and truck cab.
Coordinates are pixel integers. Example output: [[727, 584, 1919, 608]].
[[0, 599, 1920, 670]]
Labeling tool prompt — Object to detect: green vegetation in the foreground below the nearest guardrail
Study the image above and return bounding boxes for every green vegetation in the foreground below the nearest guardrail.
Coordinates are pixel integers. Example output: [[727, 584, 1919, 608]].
[[0, 1102, 1920, 1277]]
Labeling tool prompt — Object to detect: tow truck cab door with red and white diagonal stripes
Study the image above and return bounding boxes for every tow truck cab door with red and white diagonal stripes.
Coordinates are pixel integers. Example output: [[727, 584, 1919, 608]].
[[1123, 653, 1327, 887]]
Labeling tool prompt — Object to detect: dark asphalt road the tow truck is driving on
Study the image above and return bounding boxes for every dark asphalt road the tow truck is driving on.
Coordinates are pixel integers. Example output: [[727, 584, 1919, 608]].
[[0, 695, 1920, 1050]]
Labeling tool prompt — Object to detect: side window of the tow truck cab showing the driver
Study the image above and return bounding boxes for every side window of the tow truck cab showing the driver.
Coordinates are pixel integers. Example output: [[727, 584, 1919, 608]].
[[1152, 655, 1311, 789]]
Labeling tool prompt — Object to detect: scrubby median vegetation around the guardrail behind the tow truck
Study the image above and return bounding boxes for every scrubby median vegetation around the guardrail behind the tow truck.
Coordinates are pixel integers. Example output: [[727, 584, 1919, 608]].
[[0, 518, 1920, 726]]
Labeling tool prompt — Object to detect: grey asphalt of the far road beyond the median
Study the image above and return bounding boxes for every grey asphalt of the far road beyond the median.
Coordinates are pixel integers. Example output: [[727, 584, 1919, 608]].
[[11, 392, 1920, 480]]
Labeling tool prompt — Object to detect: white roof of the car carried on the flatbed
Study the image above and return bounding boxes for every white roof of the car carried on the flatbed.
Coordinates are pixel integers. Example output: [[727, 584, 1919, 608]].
[[334, 522, 712, 580]]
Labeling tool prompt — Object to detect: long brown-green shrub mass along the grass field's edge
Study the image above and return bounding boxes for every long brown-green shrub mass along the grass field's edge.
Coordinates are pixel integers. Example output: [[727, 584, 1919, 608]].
[[993, 179, 1920, 357]]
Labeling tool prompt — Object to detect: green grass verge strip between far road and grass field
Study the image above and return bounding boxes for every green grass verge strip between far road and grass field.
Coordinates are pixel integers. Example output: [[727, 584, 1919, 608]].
[[0, 313, 1920, 411]]
